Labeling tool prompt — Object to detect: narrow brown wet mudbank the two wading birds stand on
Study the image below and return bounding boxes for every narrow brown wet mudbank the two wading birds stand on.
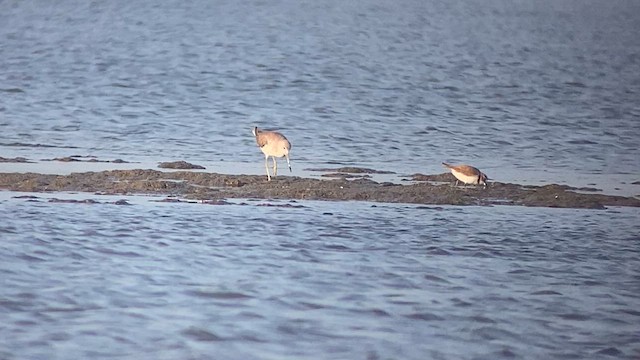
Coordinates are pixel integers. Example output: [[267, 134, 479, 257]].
[[0, 168, 640, 209]]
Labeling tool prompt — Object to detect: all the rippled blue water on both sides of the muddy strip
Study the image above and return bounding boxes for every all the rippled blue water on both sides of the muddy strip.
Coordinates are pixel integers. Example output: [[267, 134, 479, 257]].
[[0, 0, 640, 359]]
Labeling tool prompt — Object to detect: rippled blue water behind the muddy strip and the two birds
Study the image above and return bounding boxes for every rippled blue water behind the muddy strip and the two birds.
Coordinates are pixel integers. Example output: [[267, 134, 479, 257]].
[[0, 0, 640, 181]]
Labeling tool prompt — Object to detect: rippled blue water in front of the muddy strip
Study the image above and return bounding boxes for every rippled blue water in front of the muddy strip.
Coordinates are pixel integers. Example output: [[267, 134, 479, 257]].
[[0, 192, 640, 359]]
